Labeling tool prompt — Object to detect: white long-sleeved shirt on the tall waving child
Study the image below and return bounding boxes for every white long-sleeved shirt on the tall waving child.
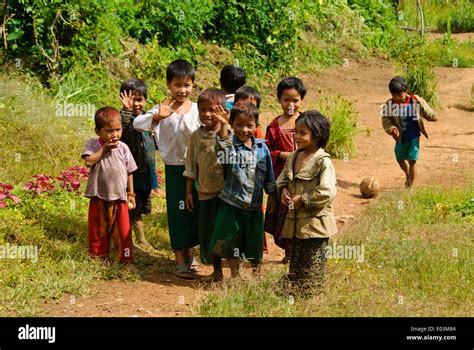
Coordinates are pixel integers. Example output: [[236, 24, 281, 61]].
[[133, 102, 201, 165]]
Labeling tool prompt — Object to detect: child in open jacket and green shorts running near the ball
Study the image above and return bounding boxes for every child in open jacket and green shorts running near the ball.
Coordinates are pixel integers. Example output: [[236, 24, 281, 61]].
[[381, 76, 437, 188]]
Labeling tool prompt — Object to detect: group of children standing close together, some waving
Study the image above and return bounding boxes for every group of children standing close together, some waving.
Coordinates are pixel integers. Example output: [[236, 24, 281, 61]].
[[82, 60, 436, 291]]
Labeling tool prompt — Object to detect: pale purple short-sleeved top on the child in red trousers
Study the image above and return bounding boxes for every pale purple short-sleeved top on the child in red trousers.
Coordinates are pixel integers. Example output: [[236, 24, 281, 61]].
[[81, 139, 137, 201]]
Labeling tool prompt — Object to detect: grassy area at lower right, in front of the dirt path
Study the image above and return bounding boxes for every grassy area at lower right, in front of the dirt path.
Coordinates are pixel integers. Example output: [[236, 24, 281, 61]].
[[194, 186, 474, 317]]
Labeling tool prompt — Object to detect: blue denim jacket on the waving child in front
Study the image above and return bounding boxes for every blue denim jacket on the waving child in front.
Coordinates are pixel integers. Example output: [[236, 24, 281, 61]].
[[216, 135, 276, 210]]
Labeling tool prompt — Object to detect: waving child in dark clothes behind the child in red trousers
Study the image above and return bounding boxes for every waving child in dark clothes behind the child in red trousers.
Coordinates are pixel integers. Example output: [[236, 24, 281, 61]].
[[120, 78, 158, 247]]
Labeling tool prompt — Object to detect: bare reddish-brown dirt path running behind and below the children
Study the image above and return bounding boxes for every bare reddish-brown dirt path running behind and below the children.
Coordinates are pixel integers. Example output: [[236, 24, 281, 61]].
[[42, 59, 474, 317]]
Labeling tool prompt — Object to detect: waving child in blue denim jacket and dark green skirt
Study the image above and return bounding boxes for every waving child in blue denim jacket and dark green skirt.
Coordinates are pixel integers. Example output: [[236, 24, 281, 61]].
[[211, 103, 275, 277]]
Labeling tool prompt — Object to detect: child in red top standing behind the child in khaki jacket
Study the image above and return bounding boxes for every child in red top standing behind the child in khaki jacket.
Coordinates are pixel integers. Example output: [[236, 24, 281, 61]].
[[265, 77, 306, 263]]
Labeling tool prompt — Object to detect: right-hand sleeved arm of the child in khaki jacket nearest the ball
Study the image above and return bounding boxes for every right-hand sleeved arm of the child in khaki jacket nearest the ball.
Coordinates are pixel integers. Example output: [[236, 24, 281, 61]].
[[301, 157, 337, 209]]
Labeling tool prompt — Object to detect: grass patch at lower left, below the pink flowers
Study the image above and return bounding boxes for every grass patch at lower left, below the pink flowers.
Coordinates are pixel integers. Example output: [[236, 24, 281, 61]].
[[0, 183, 172, 316]]
